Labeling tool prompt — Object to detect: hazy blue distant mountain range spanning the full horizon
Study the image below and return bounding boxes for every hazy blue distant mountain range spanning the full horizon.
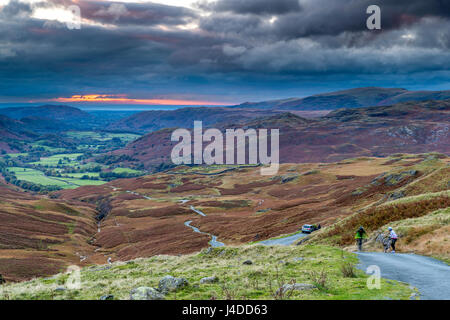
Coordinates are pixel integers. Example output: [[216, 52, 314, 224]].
[[0, 87, 450, 156]]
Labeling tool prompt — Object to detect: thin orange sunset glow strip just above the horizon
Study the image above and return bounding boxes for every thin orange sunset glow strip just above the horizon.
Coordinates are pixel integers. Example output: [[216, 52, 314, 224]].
[[51, 94, 226, 106]]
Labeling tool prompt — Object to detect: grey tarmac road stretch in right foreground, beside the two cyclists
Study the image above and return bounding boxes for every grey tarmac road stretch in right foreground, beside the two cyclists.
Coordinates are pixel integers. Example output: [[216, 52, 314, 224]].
[[358, 252, 450, 300]]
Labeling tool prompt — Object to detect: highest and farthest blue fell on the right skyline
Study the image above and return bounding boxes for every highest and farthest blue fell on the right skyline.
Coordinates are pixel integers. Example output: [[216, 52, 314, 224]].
[[235, 87, 450, 110]]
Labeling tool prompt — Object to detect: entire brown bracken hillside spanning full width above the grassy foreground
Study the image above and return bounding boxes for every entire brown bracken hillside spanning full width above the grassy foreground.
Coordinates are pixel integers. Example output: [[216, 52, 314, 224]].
[[0, 154, 450, 288]]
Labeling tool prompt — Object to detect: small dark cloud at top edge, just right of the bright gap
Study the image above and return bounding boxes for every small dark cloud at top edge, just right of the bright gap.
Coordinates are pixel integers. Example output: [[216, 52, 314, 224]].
[[198, 0, 301, 14]]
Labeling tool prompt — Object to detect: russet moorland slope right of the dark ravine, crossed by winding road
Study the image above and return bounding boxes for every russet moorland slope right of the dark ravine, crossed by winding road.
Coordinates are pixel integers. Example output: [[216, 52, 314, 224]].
[[51, 155, 449, 266]]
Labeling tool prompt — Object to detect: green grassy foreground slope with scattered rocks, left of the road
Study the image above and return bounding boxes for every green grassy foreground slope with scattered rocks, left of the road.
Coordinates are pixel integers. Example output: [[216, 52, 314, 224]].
[[0, 245, 414, 300]]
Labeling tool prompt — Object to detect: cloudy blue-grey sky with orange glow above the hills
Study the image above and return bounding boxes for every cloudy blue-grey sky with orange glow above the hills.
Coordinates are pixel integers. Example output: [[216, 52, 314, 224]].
[[0, 0, 450, 106]]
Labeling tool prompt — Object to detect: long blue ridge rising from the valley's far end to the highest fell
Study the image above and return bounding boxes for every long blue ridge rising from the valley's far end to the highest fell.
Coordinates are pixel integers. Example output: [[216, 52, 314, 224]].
[[106, 87, 450, 133]]
